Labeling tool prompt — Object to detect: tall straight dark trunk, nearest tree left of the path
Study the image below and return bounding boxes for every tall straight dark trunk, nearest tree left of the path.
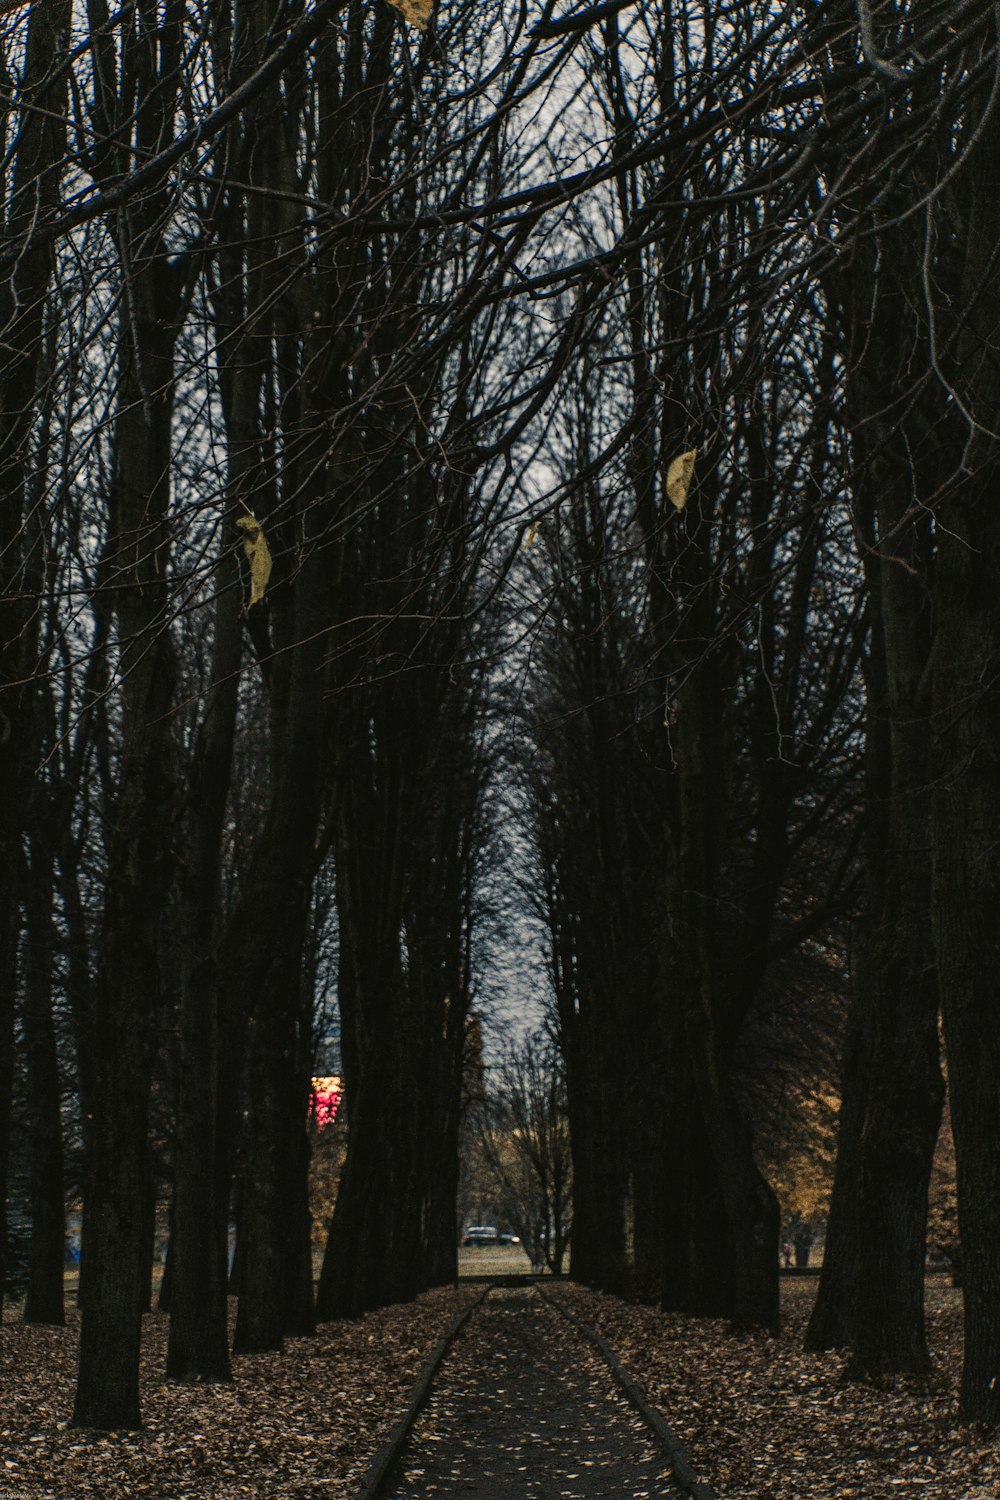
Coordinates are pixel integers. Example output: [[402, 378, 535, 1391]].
[[73, 246, 177, 1428]]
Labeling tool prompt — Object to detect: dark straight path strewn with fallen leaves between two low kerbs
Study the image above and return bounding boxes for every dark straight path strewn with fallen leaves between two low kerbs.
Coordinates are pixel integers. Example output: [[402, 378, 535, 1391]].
[[384, 1287, 684, 1500]]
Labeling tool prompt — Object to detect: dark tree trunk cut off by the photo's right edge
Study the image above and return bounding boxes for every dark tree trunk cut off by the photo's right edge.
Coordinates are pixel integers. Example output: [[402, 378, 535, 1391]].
[[933, 87, 1000, 1427]]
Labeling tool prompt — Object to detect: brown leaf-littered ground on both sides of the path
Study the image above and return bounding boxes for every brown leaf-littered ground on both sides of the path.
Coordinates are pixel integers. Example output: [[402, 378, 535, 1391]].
[[0, 1278, 1000, 1500]]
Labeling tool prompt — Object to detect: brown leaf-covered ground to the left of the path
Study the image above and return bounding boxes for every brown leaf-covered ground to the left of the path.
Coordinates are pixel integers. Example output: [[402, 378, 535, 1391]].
[[0, 1287, 480, 1500]]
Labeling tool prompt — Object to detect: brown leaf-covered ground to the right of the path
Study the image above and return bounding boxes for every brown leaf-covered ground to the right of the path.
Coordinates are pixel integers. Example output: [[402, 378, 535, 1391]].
[[556, 1277, 1000, 1500]]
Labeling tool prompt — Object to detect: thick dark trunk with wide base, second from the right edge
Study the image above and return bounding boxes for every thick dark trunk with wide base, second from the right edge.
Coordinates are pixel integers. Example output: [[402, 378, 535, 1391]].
[[808, 219, 946, 1377]]
